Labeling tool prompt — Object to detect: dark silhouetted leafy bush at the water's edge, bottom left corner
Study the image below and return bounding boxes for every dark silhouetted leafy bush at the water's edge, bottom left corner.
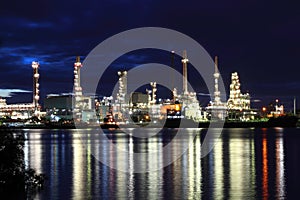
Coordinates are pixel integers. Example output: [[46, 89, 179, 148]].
[[0, 130, 45, 199]]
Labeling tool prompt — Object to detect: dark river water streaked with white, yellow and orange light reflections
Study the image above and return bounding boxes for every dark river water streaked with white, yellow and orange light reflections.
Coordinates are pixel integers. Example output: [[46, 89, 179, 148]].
[[24, 129, 300, 199]]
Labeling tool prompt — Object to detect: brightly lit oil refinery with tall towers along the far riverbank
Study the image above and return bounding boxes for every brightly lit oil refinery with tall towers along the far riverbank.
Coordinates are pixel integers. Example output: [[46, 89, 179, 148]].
[[0, 51, 295, 128]]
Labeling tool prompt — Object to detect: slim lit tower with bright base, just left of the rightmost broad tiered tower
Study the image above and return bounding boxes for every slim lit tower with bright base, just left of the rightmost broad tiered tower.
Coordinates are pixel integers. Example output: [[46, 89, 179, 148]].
[[207, 56, 227, 120]]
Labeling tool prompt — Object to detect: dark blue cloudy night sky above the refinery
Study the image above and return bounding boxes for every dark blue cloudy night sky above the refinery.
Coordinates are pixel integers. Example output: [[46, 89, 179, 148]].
[[0, 0, 300, 108]]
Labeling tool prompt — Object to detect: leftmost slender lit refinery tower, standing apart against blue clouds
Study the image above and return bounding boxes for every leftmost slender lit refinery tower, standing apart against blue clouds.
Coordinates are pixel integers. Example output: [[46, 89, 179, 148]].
[[31, 61, 40, 115]]
